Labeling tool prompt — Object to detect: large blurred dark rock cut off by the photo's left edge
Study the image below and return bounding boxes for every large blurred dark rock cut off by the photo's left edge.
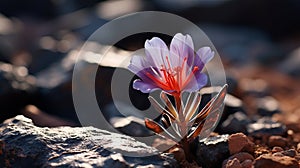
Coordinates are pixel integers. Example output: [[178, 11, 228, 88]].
[[0, 62, 37, 122]]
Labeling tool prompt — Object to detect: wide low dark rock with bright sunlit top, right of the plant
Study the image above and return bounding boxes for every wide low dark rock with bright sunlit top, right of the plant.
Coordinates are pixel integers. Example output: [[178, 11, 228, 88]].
[[247, 117, 287, 137]]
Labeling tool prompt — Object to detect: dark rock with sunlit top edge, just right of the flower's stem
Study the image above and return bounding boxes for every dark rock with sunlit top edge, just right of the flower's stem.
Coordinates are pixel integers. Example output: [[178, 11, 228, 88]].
[[193, 134, 229, 168]]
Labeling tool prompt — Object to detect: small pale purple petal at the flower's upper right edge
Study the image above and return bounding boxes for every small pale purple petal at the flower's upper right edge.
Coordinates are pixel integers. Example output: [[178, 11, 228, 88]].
[[194, 47, 215, 69]]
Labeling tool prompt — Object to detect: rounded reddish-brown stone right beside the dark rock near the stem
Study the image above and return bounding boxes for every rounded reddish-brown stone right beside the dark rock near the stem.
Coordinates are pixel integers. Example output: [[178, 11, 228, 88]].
[[228, 133, 254, 154]]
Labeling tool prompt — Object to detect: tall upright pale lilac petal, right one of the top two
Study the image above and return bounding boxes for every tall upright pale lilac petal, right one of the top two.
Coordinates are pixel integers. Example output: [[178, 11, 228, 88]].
[[170, 33, 194, 66]]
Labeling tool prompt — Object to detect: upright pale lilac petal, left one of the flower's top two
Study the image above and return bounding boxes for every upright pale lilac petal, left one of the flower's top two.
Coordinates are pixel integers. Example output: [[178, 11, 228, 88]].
[[145, 37, 169, 67]]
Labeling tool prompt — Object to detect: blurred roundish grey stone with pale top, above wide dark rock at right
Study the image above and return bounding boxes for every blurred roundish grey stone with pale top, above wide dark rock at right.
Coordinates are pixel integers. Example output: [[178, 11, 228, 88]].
[[257, 96, 281, 116]]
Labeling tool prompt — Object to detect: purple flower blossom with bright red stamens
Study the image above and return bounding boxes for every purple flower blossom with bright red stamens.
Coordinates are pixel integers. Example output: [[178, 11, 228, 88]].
[[128, 33, 214, 94]]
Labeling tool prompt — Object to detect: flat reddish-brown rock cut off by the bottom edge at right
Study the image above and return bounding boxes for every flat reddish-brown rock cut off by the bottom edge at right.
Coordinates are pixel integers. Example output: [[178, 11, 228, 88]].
[[254, 154, 299, 168]]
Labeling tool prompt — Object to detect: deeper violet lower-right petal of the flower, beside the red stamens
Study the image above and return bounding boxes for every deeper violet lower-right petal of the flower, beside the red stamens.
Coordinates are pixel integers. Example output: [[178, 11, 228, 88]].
[[184, 71, 207, 92]]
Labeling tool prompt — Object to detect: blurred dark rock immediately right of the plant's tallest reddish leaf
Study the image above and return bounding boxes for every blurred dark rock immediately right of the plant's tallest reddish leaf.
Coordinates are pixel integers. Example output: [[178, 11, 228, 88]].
[[218, 112, 251, 134]]
